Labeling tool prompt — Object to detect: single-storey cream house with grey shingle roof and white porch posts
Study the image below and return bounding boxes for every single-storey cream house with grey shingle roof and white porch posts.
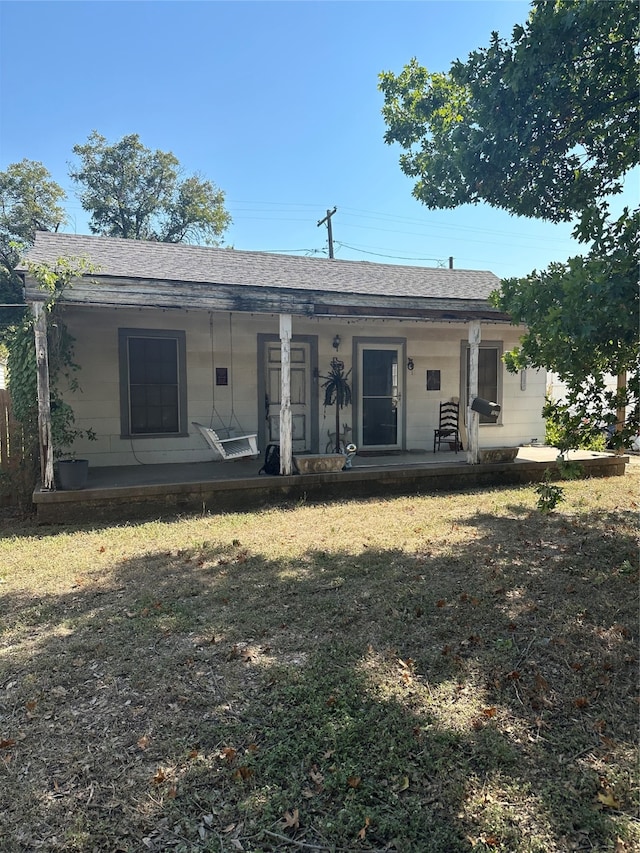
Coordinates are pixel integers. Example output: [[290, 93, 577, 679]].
[[23, 232, 545, 484]]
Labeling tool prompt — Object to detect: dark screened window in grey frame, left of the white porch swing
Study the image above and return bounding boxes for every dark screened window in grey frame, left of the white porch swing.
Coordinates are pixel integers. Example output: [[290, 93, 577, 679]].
[[118, 329, 187, 436]]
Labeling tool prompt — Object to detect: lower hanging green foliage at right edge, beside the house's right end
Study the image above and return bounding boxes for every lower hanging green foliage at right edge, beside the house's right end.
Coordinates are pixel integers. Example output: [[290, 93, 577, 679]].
[[494, 212, 640, 446]]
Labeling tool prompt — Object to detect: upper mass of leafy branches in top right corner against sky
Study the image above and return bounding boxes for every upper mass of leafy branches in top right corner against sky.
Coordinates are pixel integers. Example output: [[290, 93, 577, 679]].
[[380, 0, 639, 222]]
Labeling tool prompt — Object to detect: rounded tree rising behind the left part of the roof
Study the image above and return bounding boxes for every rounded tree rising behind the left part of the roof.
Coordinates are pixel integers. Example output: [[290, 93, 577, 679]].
[[69, 131, 231, 245]]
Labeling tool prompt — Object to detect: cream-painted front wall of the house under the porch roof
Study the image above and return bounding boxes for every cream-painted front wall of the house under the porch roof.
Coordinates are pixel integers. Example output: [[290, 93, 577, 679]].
[[58, 305, 546, 466]]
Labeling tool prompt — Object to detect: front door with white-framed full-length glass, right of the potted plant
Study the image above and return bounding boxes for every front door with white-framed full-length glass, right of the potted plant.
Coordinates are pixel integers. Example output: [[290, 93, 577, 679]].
[[357, 343, 403, 450]]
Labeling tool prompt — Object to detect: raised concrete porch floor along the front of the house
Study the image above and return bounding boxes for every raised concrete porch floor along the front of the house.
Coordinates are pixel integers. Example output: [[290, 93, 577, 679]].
[[33, 446, 629, 524]]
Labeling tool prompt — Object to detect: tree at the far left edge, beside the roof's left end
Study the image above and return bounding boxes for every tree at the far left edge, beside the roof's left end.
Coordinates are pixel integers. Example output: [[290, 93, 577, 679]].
[[0, 160, 66, 328]]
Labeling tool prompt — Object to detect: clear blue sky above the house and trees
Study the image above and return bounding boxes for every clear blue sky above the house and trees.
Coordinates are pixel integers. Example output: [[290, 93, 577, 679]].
[[0, 0, 636, 278]]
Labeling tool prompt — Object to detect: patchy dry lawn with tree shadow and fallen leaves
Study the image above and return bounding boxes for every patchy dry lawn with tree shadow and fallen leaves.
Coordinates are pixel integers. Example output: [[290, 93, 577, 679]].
[[0, 465, 640, 853]]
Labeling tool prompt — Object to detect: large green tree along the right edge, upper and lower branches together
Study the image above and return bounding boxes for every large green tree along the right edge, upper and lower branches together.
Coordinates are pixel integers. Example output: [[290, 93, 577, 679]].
[[380, 0, 640, 446]]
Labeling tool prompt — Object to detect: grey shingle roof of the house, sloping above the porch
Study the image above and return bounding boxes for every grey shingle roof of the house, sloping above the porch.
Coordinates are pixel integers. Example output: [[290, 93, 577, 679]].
[[27, 232, 499, 300]]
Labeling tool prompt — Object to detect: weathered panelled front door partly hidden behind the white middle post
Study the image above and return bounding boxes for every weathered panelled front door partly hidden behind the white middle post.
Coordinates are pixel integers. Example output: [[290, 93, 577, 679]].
[[264, 341, 311, 453]]
